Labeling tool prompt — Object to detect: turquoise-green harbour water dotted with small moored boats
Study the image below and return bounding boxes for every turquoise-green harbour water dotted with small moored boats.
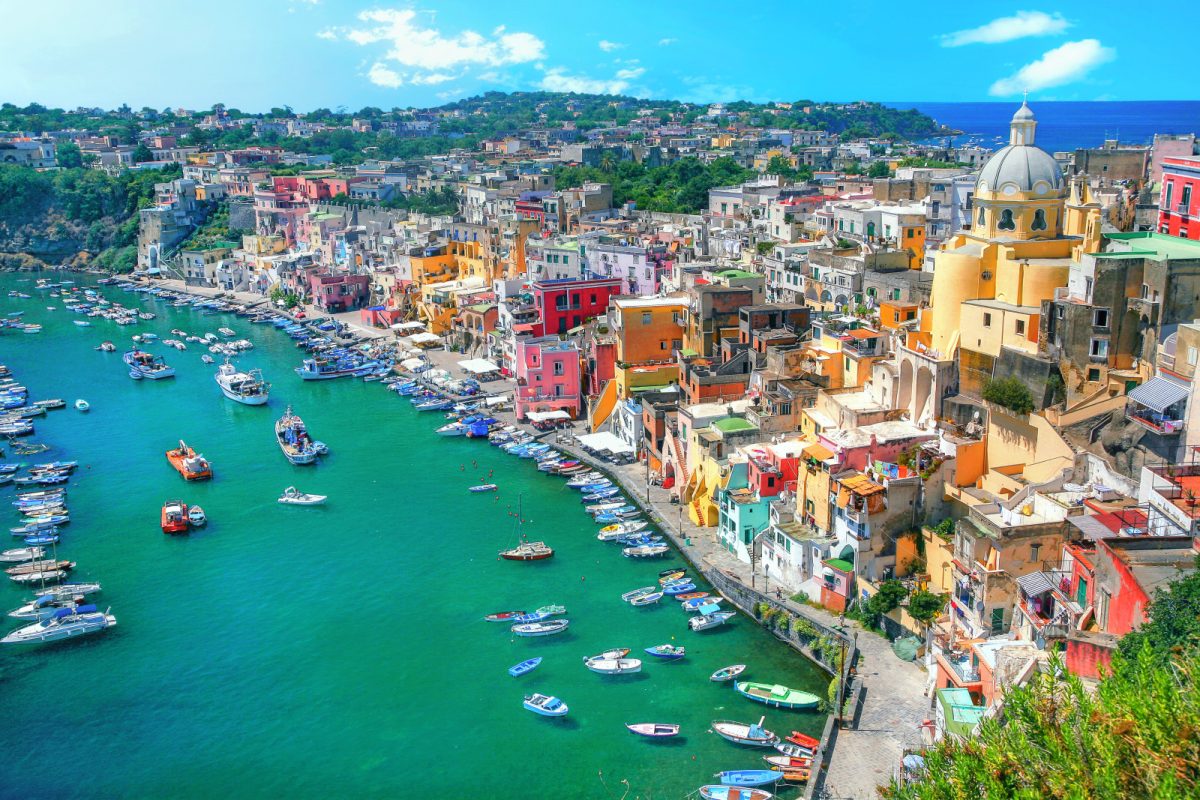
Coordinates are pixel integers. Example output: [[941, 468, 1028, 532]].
[[0, 275, 827, 799]]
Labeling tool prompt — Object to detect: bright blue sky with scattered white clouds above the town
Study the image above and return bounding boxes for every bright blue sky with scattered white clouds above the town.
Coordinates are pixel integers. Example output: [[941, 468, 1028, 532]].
[[0, 0, 1200, 110]]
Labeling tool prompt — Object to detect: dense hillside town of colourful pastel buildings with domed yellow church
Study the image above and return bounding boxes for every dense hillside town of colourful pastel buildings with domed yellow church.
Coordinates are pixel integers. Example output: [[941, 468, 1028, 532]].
[[7, 92, 1200, 786]]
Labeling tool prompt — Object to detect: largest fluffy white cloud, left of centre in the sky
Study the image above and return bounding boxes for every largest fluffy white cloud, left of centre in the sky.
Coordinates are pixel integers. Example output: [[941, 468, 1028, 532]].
[[344, 8, 546, 71]]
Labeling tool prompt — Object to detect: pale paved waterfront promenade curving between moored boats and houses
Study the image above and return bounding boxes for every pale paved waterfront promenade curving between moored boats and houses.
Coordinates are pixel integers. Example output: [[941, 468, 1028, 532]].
[[140, 281, 932, 800]]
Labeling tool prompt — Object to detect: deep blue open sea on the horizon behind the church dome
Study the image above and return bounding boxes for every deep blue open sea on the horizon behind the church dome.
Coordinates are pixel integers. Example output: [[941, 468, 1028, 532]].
[[887, 101, 1200, 152]]
